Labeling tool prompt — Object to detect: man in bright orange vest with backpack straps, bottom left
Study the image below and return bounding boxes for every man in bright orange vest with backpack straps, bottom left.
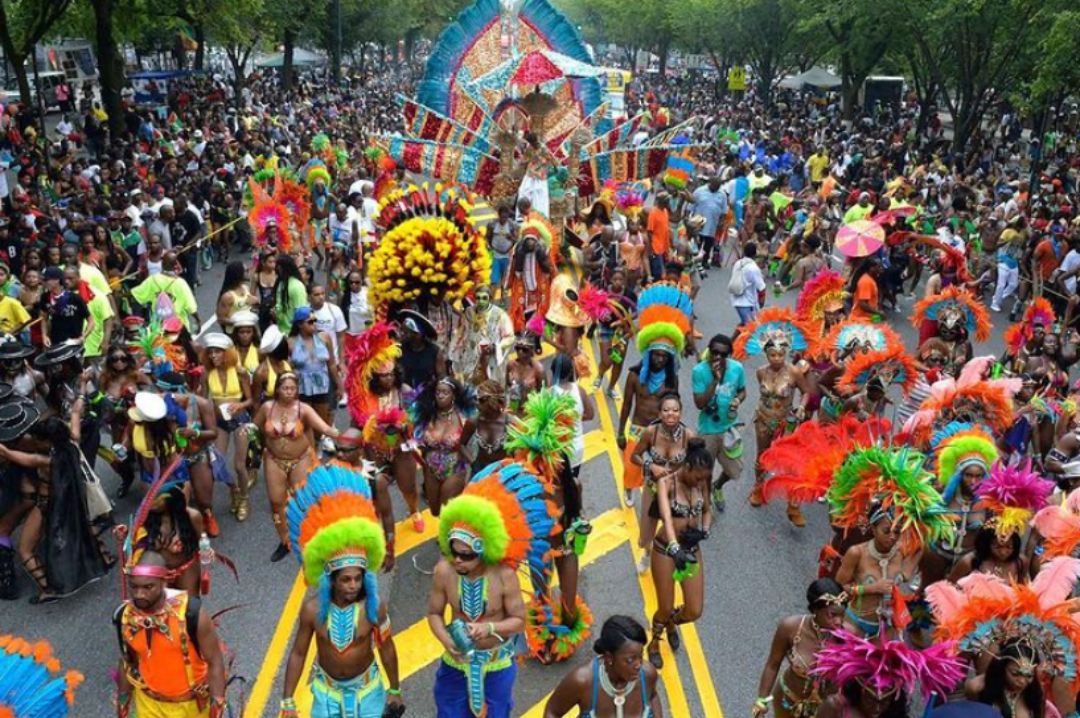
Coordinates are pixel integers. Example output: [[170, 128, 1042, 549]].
[[112, 551, 226, 718]]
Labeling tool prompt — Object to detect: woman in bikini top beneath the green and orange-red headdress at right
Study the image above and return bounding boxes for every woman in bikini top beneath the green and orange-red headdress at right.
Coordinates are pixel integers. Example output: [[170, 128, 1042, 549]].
[[836, 505, 923, 637]]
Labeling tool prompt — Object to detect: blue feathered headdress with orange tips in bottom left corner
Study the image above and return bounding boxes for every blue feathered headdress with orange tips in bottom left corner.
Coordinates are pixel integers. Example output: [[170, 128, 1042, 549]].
[[0, 636, 83, 718]]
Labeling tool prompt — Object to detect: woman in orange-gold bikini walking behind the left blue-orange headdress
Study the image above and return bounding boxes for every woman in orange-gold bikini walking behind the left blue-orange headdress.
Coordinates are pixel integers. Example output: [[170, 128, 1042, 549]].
[[255, 371, 340, 563]]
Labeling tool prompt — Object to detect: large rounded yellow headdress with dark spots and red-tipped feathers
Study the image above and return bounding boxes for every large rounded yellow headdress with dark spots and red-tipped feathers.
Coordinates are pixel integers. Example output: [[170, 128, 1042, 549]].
[[368, 182, 491, 314]]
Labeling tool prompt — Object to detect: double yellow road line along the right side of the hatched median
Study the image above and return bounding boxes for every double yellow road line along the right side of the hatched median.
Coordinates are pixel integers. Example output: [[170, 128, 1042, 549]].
[[583, 342, 724, 718]]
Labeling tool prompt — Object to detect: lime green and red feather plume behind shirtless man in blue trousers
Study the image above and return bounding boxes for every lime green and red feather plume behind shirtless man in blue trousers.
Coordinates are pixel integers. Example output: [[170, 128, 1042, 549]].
[[505, 388, 578, 483]]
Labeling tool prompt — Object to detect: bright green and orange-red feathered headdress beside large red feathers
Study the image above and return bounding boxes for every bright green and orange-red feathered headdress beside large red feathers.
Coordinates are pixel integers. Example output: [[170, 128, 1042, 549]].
[[825, 447, 956, 554]]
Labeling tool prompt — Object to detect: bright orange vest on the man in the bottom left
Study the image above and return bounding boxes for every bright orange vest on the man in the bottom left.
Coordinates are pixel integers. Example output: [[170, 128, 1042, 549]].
[[120, 588, 208, 700]]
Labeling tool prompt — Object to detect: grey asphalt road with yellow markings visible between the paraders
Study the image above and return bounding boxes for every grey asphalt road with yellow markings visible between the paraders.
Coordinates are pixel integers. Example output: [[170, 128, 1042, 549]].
[[8, 244, 1007, 718]]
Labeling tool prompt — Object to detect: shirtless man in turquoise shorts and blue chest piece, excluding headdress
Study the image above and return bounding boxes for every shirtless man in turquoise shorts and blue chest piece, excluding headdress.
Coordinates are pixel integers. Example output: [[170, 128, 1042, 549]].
[[279, 566, 405, 718]]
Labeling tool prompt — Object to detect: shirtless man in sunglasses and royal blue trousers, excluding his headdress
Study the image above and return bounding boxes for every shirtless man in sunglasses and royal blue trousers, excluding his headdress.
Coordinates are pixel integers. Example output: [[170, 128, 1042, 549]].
[[428, 526, 525, 718]]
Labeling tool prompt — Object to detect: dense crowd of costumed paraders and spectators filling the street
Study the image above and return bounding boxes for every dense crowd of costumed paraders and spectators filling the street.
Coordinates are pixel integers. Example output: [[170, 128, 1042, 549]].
[[0, 32, 1080, 718]]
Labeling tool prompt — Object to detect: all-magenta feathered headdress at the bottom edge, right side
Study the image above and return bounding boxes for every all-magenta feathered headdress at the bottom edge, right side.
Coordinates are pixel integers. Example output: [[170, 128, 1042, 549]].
[[810, 628, 968, 700]]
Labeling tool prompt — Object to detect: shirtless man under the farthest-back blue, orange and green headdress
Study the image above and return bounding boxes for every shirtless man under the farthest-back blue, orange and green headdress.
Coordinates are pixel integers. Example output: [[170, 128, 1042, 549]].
[[616, 351, 678, 506]]
